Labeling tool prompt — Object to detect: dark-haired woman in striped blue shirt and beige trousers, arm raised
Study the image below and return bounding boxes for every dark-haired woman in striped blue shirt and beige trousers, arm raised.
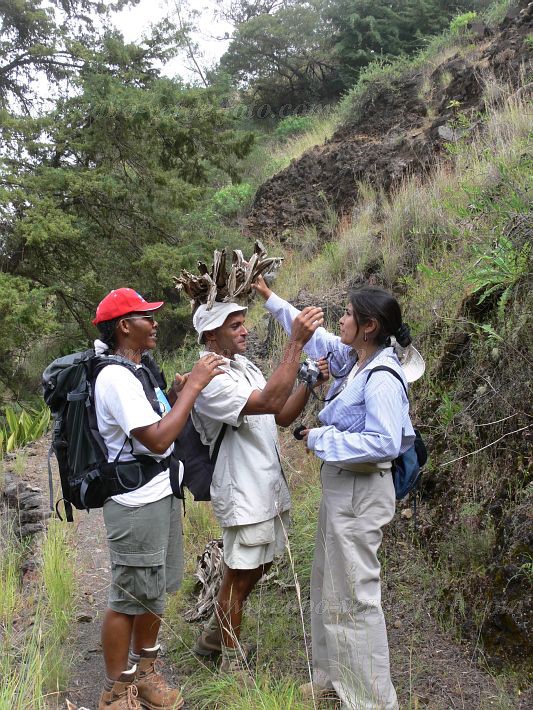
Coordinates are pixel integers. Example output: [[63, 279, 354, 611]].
[[255, 279, 415, 710]]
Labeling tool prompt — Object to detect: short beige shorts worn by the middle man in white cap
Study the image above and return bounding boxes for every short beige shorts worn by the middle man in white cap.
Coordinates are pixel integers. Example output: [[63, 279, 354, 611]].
[[222, 510, 290, 569]]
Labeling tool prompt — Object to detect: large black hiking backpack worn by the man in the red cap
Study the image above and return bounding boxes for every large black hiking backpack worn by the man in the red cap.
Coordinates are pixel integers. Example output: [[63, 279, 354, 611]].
[[42, 349, 170, 522]]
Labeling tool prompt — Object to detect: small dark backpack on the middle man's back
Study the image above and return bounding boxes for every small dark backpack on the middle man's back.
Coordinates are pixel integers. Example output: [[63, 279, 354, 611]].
[[170, 415, 227, 500]]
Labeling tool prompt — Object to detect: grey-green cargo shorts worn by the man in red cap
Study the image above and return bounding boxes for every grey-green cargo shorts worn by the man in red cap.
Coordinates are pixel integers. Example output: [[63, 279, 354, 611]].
[[104, 495, 183, 615]]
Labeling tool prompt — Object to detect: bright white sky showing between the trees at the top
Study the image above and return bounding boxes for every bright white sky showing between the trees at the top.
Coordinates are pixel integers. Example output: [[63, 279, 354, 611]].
[[114, 0, 232, 81]]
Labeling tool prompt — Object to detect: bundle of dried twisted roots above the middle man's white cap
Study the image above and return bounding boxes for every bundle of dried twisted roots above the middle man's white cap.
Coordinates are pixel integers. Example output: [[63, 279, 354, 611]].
[[174, 240, 283, 311]]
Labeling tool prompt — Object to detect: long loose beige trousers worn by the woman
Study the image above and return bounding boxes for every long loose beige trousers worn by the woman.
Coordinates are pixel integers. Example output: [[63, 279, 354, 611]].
[[311, 463, 398, 710]]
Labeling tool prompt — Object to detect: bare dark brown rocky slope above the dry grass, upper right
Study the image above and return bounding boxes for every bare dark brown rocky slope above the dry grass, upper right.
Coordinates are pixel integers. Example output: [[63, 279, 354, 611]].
[[247, 3, 533, 239]]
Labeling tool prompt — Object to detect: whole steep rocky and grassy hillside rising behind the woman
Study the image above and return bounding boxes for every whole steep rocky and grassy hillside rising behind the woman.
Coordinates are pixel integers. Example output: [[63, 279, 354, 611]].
[[247, 2, 533, 667]]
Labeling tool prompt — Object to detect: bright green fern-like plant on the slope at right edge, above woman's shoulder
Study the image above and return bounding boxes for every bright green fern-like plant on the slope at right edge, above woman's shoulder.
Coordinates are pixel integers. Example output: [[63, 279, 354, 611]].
[[469, 236, 531, 320]]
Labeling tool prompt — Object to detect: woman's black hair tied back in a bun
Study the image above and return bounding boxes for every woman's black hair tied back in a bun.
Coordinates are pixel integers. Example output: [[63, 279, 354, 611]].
[[348, 286, 412, 348]]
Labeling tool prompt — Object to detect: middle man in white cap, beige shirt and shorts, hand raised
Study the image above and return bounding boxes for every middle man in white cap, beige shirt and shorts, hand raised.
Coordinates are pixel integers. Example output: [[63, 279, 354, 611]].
[[192, 302, 324, 681]]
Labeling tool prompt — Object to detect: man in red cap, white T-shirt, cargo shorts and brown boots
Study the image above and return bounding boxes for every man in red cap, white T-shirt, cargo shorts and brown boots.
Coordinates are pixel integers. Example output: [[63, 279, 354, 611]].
[[93, 288, 222, 710]]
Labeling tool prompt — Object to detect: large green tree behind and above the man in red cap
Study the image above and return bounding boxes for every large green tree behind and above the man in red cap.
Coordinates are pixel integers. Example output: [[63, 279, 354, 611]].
[[0, 35, 252, 383]]
